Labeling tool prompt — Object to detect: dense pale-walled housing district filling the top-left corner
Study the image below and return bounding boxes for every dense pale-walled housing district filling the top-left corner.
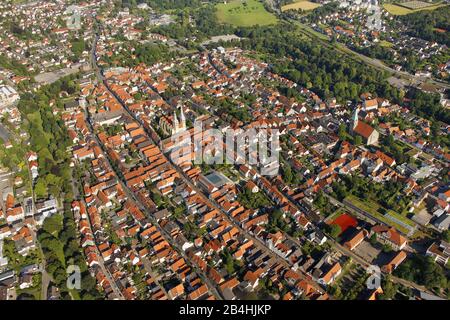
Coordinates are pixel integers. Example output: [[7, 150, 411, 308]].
[[0, 0, 100, 80]]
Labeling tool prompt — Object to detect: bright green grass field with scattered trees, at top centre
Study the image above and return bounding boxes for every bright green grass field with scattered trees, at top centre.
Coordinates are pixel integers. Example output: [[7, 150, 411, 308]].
[[216, 0, 278, 27]]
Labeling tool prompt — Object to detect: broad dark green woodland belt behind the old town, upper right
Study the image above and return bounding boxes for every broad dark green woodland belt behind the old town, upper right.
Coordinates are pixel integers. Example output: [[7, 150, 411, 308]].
[[238, 24, 401, 103]]
